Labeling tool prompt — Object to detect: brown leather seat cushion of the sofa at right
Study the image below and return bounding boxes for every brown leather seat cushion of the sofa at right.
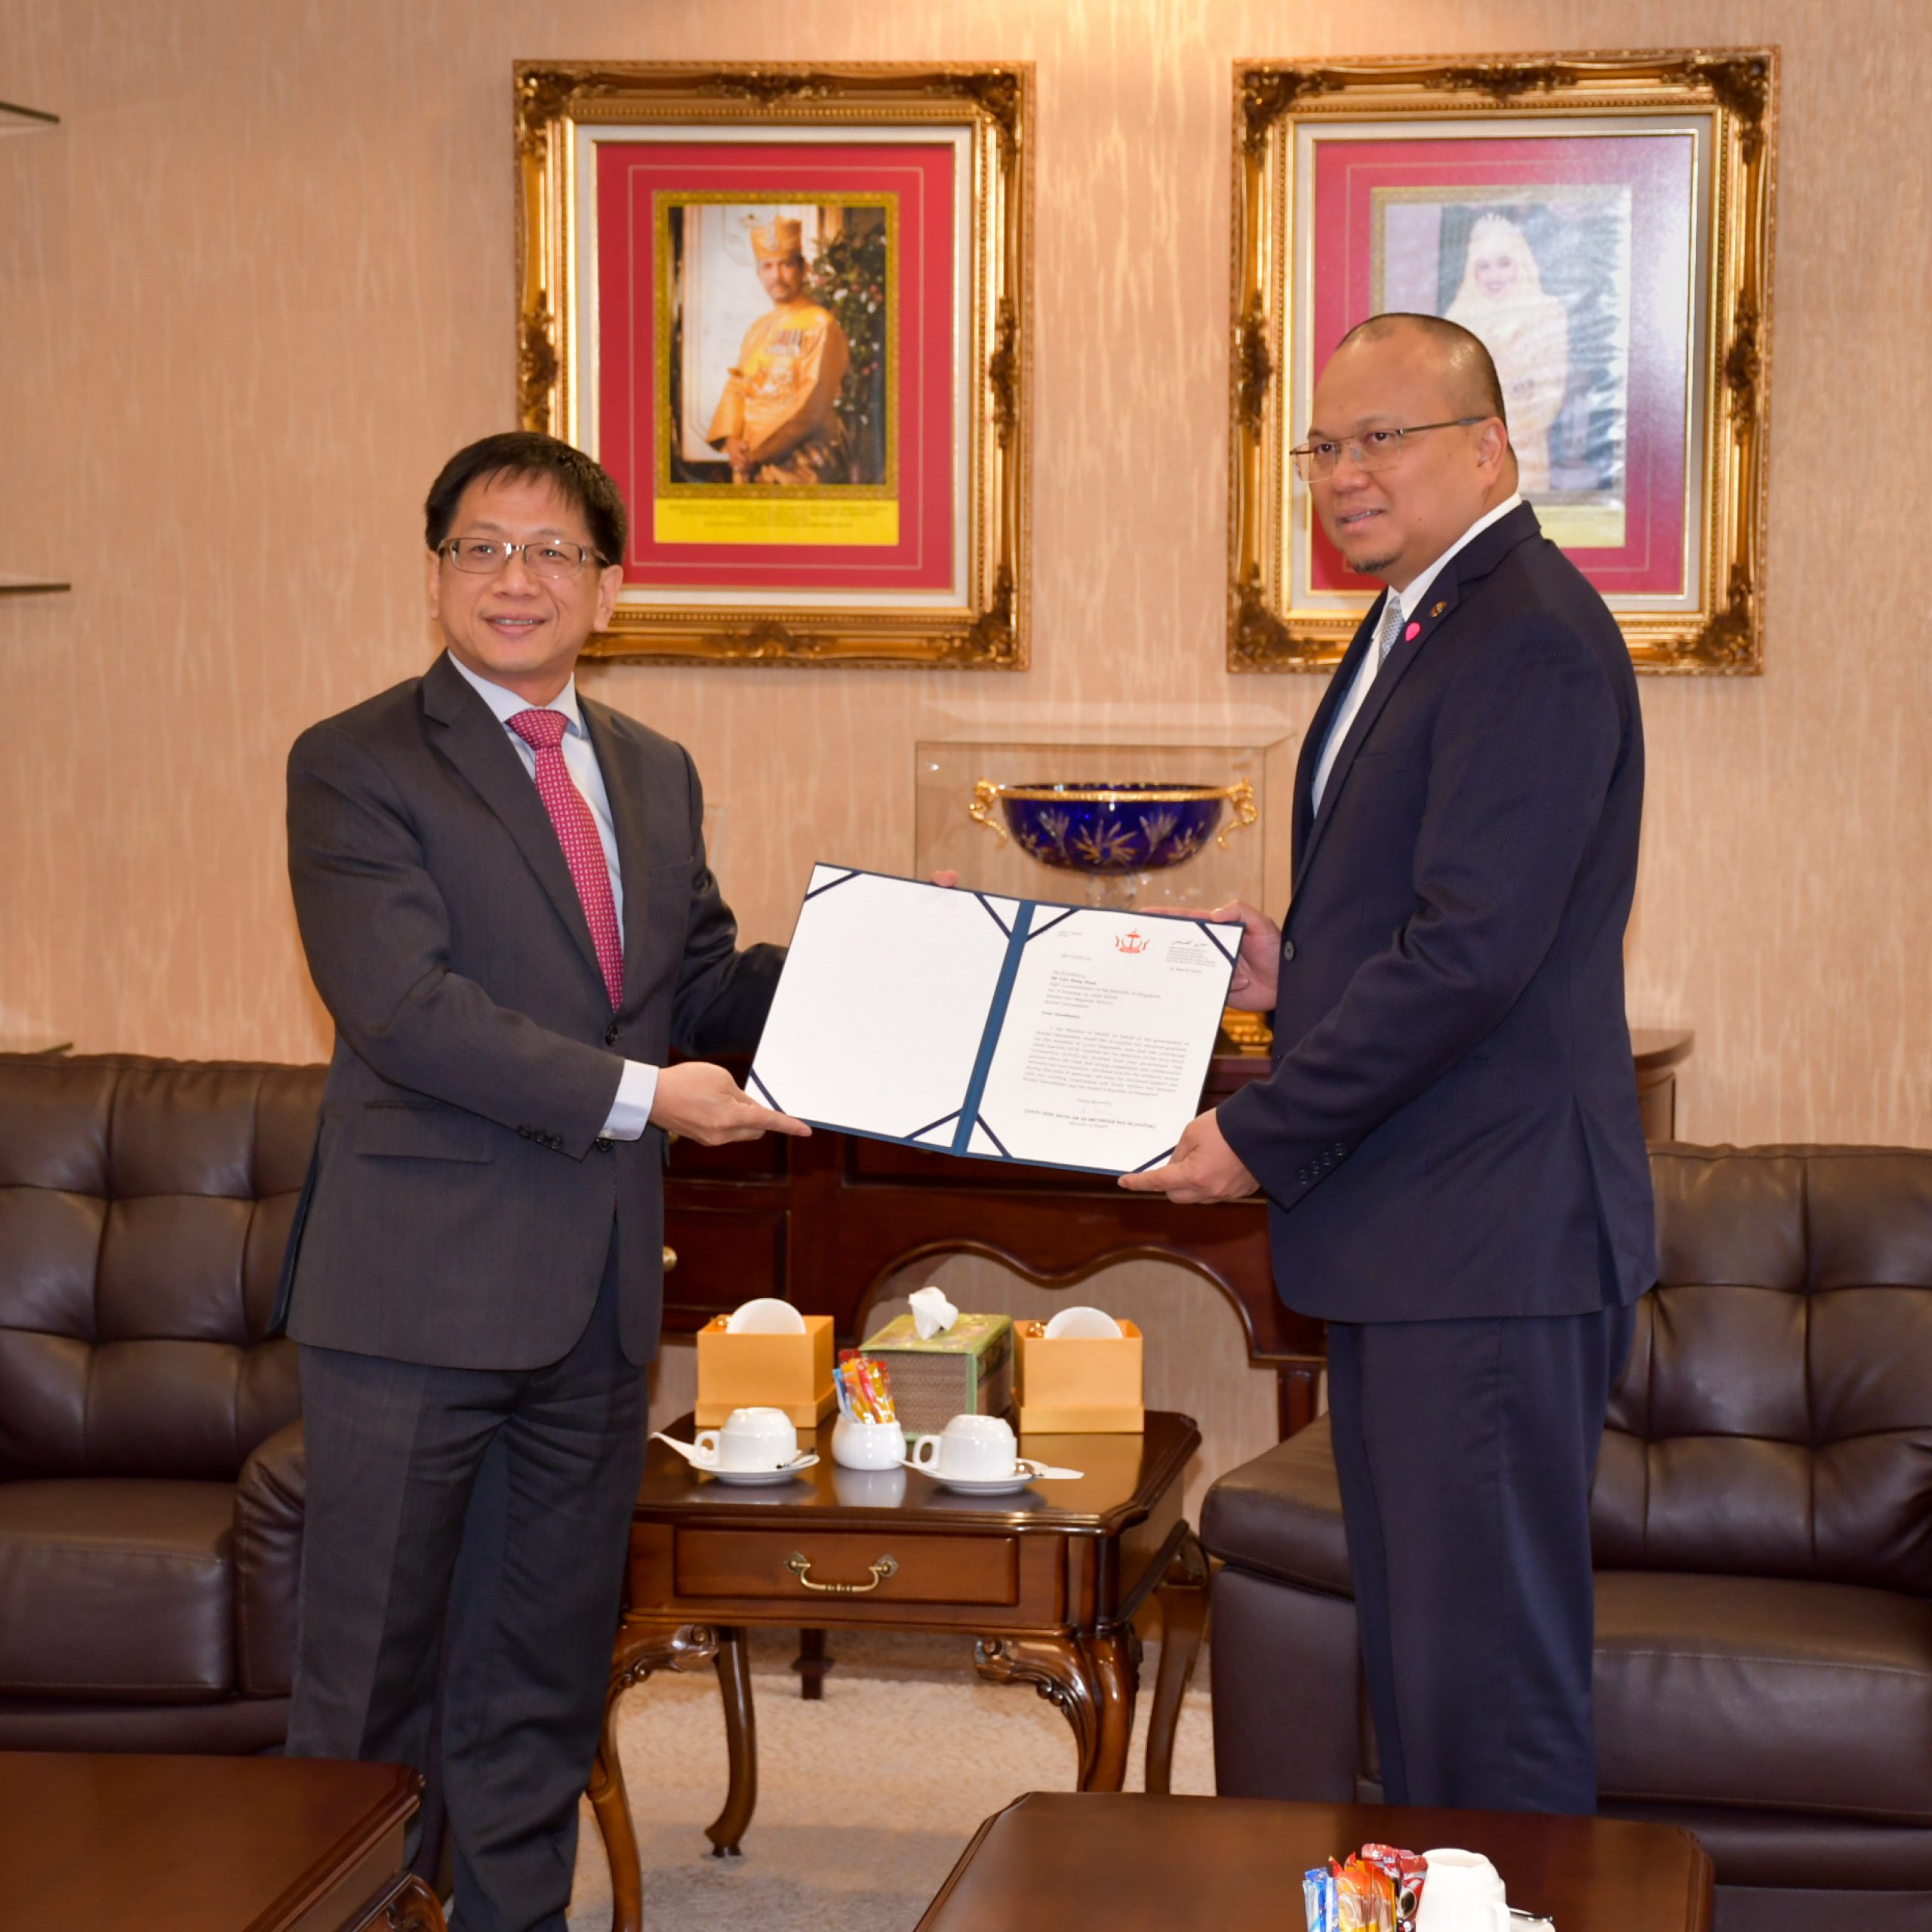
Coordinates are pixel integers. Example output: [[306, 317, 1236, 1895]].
[[1596, 1571, 1932, 1826]]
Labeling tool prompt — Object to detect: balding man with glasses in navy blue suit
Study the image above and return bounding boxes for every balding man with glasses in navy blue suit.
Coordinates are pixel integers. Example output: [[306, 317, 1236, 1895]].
[[1122, 315, 1656, 1812]]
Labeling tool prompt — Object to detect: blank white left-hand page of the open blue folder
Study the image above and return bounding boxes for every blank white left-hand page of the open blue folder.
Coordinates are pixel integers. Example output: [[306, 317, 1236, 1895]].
[[752, 866, 1018, 1148]]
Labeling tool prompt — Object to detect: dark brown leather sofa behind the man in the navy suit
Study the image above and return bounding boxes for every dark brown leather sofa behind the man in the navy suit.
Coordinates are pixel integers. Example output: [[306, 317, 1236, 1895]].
[[1204, 1146, 1932, 1932]]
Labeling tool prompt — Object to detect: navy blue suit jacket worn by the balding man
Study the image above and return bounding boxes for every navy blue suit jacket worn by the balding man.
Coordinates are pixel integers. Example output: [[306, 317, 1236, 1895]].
[[1219, 506, 1656, 1321]]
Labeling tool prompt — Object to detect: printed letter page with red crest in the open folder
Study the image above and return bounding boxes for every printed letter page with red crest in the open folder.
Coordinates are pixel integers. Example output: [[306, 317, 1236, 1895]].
[[974, 908, 1241, 1174]]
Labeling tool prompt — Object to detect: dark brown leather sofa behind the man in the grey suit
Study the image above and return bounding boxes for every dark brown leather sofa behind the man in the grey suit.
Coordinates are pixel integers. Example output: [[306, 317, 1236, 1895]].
[[0, 1055, 323, 1752]]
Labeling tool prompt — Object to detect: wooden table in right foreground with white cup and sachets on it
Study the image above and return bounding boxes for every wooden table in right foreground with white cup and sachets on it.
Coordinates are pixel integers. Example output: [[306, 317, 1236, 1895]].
[[918, 1793, 1712, 1932]]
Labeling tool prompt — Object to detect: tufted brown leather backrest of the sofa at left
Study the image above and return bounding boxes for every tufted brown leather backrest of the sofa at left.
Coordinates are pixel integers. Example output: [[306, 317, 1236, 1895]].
[[0, 1055, 323, 1482]]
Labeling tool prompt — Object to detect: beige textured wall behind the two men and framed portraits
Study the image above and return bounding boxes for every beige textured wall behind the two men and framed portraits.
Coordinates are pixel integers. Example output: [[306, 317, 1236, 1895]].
[[0, 0, 1932, 1142]]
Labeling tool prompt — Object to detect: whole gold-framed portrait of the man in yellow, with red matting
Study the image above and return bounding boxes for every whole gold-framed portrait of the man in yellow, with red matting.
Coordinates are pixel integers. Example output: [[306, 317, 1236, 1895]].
[[514, 60, 1034, 670]]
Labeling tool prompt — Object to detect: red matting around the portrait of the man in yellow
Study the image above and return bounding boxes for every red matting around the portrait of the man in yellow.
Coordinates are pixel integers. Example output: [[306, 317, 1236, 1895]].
[[597, 141, 955, 593]]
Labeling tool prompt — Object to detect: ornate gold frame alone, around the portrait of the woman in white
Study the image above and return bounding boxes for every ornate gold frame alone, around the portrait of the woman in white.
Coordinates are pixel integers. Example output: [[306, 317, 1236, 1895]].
[[1227, 46, 1777, 676]]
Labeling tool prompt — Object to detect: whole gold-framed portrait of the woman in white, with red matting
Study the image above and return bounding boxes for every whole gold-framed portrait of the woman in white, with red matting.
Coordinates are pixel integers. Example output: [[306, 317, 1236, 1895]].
[[1227, 48, 1777, 676]]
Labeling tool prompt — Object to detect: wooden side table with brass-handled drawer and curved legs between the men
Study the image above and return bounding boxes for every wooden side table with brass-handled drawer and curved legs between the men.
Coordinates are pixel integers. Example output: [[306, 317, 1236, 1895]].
[[589, 1411, 1208, 1932]]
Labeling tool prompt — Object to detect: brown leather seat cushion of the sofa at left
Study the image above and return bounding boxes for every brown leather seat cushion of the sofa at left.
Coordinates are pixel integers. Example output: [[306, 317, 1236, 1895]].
[[0, 1476, 235, 1704]]
